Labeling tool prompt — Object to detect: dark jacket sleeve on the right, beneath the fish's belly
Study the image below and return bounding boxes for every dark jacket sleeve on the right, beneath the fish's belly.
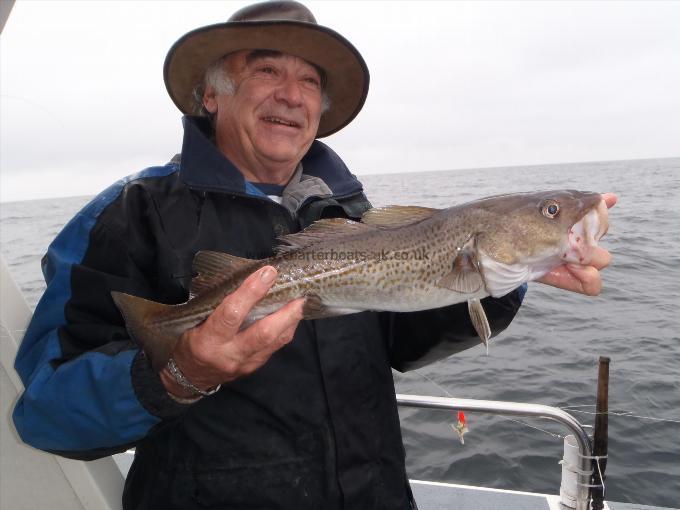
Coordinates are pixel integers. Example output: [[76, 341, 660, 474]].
[[381, 284, 527, 372]]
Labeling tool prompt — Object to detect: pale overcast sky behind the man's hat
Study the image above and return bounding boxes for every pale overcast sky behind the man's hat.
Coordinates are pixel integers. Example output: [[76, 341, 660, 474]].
[[0, 0, 680, 201]]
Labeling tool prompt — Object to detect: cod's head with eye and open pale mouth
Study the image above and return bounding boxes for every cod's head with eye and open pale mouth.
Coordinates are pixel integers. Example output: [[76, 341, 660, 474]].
[[476, 190, 609, 295]]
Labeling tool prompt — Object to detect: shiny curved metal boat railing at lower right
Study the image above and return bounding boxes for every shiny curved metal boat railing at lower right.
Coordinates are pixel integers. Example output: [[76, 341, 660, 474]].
[[397, 394, 592, 510]]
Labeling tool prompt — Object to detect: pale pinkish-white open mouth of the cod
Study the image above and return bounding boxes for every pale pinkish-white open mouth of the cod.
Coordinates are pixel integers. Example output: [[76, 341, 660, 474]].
[[562, 199, 609, 265]]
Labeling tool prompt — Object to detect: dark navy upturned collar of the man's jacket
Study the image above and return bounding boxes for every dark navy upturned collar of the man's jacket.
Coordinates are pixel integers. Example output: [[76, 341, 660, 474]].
[[179, 115, 363, 197]]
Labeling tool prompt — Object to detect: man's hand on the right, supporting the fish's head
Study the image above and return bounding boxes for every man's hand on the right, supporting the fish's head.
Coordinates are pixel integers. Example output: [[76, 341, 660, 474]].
[[538, 193, 618, 296]]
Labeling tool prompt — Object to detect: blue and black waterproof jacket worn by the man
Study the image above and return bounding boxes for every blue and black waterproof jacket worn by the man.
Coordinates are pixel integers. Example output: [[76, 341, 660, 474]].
[[14, 118, 523, 510]]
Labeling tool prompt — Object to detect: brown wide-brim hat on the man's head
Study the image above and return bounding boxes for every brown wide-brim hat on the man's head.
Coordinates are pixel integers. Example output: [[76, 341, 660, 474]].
[[163, 1, 369, 138]]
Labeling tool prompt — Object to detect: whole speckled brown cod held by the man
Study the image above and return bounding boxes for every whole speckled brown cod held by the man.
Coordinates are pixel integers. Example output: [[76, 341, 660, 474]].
[[112, 191, 608, 371]]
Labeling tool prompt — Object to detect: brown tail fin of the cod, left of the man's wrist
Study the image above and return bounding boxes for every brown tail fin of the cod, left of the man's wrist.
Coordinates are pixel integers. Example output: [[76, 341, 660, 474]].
[[111, 291, 183, 372]]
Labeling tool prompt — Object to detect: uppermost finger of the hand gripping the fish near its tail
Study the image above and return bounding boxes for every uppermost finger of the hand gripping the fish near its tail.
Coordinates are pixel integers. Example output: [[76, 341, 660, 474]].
[[210, 266, 277, 335]]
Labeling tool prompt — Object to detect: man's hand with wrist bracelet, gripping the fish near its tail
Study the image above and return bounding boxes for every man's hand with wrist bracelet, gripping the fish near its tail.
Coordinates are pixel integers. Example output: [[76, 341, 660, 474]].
[[161, 266, 304, 397]]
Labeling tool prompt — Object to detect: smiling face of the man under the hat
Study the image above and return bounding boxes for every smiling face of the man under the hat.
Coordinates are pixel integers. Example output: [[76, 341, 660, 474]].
[[204, 50, 322, 181]]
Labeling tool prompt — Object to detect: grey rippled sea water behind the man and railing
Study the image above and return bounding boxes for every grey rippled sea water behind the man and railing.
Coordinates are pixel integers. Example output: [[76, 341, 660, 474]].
[[0, 158, 680, 507]]
